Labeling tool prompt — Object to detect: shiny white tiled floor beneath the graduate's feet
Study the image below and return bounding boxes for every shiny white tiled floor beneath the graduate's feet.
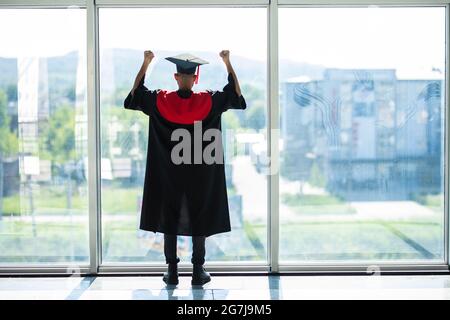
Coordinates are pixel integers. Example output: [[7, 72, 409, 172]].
[[0, 275, 450, 300]]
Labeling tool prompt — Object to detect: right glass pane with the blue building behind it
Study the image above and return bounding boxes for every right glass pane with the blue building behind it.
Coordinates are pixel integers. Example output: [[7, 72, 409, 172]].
[[279, 7, 446, 262]]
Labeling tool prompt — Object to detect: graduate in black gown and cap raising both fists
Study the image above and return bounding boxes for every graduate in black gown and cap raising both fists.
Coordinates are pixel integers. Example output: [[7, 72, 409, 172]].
[[124, 50, 247, 285]]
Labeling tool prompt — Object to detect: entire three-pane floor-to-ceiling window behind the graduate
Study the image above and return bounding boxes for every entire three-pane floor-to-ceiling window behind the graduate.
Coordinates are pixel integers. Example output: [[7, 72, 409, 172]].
[[0, 0, 450, 273]]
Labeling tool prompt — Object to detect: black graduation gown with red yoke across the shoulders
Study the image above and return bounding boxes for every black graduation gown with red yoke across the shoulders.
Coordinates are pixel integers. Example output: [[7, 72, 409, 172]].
[[124, 73, 247, 237]]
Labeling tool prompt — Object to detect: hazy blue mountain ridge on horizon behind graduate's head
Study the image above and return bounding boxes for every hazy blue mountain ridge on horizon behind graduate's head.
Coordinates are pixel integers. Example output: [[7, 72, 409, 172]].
[[0, 48, 324, 97]]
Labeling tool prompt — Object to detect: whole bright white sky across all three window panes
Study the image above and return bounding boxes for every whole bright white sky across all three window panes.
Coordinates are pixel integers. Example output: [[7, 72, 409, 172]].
[[0, 7, 445, 70]]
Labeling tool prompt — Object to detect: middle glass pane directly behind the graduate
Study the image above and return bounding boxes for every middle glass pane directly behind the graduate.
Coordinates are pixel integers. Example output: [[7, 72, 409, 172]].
[[99, 8, 267, 263]]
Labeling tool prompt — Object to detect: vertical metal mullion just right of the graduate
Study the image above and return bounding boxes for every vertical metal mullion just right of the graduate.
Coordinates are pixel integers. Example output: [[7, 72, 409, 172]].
[[267, 1, 280, 272]]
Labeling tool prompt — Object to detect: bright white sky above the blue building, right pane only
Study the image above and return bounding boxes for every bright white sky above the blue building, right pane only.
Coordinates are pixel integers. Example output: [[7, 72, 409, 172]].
[[279, 7, 445, 76]]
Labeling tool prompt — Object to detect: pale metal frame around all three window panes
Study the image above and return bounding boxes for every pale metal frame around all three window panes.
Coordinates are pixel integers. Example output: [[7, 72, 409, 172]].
[[0, 0, 450, 275]]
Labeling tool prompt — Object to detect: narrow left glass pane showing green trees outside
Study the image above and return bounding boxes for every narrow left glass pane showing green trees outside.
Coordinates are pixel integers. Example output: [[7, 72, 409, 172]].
[[0, 9, 89, 265]]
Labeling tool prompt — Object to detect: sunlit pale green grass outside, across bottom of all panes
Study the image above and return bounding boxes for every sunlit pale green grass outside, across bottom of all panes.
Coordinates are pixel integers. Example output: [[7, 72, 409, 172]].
[[0, 186, 444, 263]]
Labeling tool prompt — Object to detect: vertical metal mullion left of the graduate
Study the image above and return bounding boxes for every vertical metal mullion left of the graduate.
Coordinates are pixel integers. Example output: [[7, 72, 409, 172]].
[[86, 0, 101, 274]]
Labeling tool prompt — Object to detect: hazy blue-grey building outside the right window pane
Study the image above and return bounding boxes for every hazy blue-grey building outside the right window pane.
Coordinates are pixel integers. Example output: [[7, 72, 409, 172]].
[[280, 69, 444, 200]]
